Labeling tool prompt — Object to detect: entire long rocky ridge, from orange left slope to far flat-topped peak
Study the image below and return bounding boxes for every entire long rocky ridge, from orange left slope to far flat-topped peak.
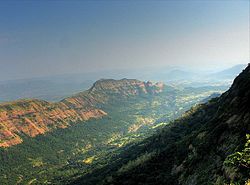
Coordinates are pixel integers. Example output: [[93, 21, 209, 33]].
[[0, 79, 163, 147]]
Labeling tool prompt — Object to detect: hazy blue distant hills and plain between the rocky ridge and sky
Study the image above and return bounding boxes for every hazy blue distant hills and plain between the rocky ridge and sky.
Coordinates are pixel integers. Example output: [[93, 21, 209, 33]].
[[0, 64, 246, 102]]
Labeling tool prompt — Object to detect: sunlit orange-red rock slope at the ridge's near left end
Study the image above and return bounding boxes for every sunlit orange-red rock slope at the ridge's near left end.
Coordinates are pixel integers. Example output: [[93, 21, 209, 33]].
[[0, 100, 106, 147]]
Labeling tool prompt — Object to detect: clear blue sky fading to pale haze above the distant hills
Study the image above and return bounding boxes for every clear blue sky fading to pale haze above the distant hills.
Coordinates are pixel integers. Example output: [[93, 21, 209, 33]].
[[0, 0, 249, 80]]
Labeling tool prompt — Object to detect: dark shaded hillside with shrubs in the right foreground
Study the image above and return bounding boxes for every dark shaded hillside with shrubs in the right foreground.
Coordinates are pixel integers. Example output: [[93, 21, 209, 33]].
[[72, 66, 250, 185]]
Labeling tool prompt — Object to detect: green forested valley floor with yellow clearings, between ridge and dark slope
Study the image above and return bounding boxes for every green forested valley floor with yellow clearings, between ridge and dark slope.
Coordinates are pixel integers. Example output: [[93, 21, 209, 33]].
[[0, 80, 225, 185]]
